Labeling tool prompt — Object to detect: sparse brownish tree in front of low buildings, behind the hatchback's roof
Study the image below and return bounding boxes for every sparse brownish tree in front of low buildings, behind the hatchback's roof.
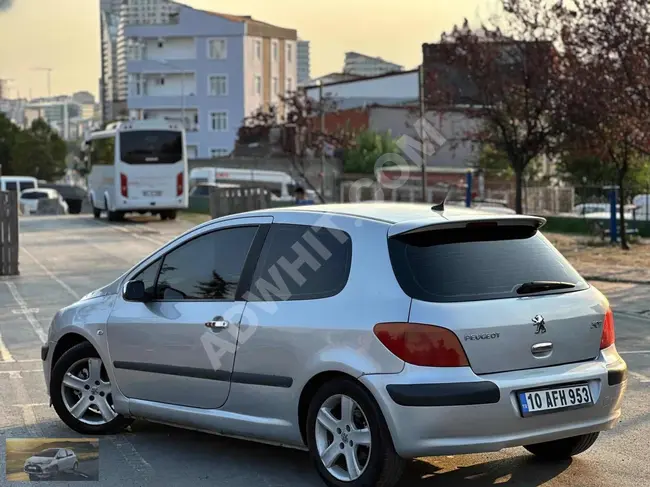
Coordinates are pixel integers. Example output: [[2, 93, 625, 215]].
[[237, 90, 356, 202]]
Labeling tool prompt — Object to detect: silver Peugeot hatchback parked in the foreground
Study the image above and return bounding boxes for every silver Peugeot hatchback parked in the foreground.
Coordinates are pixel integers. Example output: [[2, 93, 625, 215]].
[[42, 203, 627, 487]]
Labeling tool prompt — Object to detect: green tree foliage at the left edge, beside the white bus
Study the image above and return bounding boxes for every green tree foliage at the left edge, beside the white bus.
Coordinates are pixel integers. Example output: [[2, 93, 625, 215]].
[[0, 114, 68, 181]]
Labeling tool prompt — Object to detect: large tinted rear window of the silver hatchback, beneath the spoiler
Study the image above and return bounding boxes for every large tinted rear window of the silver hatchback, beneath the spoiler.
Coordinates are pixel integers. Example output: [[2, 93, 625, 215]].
[[388, 225, 589, 302]]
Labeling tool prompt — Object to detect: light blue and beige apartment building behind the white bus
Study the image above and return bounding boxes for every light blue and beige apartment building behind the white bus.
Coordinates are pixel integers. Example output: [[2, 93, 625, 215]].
[[125, 0, 298, 158]]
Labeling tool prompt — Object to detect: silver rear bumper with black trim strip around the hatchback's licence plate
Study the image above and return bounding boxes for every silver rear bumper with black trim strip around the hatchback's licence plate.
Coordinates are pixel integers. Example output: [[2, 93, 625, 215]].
[[360, 347, 627, 458]]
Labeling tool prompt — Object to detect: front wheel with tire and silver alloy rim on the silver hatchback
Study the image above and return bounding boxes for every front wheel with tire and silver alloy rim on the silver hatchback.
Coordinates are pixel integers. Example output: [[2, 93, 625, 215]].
[[50, 343, 133, 435]]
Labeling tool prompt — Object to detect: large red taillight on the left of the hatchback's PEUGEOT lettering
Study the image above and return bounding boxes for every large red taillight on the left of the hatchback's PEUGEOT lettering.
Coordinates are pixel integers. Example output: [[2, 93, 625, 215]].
[[374, 323, 469, 367]]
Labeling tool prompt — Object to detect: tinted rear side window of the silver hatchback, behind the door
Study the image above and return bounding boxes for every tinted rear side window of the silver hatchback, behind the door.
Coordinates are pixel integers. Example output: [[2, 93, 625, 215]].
[[246, 224, 352, 301]]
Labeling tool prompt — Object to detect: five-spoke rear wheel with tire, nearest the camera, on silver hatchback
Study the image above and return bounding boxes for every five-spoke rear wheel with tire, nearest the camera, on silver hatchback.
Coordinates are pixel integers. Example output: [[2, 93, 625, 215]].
[[306, 379, 406, 487]]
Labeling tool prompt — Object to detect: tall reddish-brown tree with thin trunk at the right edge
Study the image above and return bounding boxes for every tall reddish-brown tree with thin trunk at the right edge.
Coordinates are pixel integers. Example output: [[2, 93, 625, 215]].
[[553, 0, 650, 250]]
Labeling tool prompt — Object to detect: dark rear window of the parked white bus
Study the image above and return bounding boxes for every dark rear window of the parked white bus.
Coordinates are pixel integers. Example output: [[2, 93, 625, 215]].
[[120, 130, 183, 164]]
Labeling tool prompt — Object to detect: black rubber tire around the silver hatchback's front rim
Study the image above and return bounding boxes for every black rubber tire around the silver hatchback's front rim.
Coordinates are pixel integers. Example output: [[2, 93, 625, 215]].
[[50, 342, 133, 435]]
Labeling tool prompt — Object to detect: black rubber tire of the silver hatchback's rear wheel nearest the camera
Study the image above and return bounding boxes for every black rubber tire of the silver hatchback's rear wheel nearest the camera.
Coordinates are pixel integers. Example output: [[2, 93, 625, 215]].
[[306, 379, 406, 487]]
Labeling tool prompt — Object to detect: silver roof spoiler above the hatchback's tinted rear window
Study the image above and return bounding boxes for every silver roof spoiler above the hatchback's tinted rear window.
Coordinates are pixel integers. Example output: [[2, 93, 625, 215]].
[[388, 215, 546, 238]]
